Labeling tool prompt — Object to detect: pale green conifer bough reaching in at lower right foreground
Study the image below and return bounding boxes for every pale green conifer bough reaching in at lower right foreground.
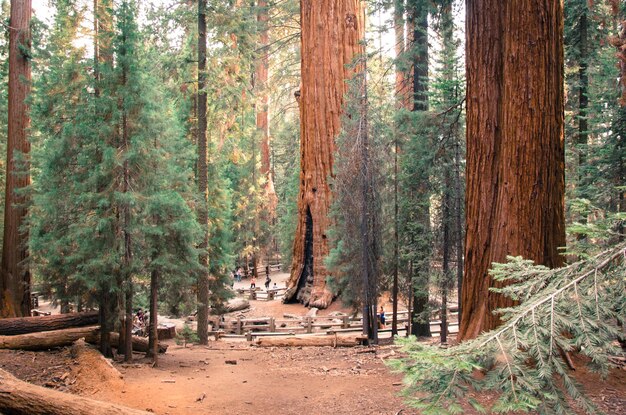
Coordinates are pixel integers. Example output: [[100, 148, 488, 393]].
[[389, 244, 626, 415]]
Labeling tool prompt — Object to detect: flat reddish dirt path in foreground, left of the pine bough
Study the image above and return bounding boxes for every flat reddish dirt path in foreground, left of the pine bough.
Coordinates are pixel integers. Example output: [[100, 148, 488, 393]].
[[104, 344, 403, 415]]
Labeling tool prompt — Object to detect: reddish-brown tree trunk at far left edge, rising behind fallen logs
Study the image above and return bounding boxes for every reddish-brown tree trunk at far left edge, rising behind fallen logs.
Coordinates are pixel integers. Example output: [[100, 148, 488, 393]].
[[0, 0, 32, 317]]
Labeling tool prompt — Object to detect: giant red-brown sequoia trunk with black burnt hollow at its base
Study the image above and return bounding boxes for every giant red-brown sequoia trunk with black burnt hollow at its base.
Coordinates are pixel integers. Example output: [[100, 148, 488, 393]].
[[285, 0, 365, 308]]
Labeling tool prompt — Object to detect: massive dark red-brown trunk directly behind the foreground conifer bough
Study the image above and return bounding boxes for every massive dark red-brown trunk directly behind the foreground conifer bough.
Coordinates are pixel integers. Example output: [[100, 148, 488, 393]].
[[459, 0, 565, 339]]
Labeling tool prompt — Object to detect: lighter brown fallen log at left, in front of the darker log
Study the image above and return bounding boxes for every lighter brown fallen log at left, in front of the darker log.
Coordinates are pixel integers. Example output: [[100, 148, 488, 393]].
[[0, 326, 99, 350]]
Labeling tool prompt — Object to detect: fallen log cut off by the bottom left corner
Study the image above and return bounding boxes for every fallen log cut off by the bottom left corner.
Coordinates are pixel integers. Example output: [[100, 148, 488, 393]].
[[0, 369, 150, 415]]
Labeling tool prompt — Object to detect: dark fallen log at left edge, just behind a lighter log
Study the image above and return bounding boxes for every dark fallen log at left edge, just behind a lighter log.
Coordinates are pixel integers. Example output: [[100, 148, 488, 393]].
[[0, 311, 98, 336]]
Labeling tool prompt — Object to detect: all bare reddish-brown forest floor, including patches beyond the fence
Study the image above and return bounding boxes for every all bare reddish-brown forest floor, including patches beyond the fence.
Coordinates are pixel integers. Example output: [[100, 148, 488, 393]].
[[0, 276, 626, 415]]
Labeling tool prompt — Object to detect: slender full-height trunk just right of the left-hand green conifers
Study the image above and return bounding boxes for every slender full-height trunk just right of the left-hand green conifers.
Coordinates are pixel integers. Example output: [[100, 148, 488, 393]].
[[197, 0, 209, 344]]
